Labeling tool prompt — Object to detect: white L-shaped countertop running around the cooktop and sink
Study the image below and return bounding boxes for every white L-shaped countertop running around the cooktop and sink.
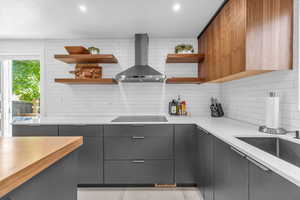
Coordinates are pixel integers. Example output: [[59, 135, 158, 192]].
[[14, 117, 300, 187]]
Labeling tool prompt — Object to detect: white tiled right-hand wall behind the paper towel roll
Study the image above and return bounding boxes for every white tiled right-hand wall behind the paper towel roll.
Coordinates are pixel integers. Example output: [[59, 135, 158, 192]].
[[221, 70, 300, 129]]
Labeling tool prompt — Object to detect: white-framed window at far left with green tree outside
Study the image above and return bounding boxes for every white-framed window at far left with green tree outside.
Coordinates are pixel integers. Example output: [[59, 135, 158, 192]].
[[0, 58, 41, 136]]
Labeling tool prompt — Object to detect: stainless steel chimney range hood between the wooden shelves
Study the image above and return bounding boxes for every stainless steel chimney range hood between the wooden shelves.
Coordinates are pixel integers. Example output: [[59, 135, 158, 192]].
[[115, 34, 166, 82]]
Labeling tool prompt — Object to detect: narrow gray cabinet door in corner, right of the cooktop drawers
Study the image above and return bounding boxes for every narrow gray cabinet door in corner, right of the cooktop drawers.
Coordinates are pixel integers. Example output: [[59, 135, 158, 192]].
[[175, 125, 196, 184]]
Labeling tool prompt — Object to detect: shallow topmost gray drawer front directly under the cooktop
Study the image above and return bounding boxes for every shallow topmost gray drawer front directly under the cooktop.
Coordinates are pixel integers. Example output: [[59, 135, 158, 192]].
[[104, 124, 173, 137]]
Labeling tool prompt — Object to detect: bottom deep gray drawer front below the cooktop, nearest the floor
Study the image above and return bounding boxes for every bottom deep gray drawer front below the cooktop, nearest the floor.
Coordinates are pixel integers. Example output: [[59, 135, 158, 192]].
[[104, 160, 174, 184]]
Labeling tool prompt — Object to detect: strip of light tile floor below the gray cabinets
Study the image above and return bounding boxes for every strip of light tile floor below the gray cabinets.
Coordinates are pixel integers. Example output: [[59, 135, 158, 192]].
[[78, 188, 202, 200]]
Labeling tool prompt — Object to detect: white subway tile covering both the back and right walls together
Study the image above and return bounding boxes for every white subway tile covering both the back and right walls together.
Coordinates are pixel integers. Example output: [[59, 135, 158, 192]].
[[0, 38, 300, 129]]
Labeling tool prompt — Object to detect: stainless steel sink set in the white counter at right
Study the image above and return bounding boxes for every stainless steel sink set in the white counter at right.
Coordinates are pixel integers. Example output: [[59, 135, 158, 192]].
[[237, 137, 300, 167]]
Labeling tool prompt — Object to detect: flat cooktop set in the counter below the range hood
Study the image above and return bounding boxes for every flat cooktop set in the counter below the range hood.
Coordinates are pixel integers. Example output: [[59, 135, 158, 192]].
[[112, 115, 168, 122]]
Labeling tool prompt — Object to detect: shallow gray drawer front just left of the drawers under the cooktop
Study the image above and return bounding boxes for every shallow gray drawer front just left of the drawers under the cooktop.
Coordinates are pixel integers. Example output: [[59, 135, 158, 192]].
[[59, 125, 103, 137]]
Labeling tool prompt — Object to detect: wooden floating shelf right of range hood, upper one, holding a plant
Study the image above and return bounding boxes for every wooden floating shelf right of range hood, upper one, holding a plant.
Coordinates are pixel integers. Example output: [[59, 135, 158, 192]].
[[166, 54, 205, 63]]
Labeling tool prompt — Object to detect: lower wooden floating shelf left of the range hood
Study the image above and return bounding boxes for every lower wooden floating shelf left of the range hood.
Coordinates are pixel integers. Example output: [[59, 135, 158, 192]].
[[55, 78, 118, 84]]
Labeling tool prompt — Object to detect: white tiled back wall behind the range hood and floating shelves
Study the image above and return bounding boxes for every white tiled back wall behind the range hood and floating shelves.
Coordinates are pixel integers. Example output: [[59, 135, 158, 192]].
[[0, 38, 220, 118]]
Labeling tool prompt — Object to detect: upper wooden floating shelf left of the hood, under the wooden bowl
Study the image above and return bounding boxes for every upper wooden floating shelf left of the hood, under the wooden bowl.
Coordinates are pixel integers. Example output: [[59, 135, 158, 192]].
[[54, 54, 118, 64]]
